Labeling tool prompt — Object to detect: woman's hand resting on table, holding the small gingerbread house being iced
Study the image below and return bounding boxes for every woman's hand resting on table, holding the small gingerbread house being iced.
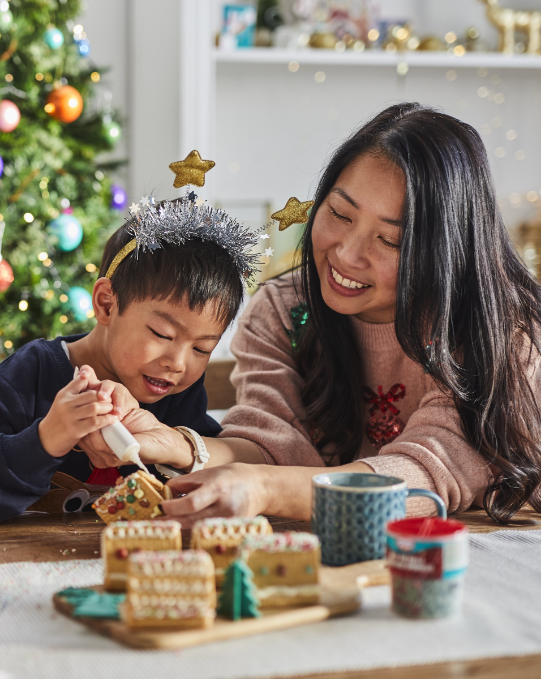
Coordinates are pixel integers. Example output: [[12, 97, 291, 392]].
[[162, 462, 266, 528]]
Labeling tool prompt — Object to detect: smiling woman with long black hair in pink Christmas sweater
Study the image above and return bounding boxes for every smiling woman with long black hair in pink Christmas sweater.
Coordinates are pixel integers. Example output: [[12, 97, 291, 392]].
[[140, 104, 541, 525]]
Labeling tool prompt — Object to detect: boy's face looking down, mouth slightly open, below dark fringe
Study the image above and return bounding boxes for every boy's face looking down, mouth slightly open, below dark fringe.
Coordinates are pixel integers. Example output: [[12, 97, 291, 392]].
[[100, 296, 225, 403]]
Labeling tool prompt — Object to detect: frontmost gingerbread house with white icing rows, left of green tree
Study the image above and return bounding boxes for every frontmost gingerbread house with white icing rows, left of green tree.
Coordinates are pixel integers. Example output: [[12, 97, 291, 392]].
[[122, 550, 216, 629]]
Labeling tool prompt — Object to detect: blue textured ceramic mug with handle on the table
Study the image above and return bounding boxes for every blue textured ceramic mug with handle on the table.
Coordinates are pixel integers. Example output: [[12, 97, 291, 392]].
[[312, 472, 447, 566]]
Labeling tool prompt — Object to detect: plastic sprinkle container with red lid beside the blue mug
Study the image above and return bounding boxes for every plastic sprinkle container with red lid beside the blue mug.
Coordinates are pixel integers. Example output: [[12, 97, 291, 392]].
[[386, 518, 469, 618]]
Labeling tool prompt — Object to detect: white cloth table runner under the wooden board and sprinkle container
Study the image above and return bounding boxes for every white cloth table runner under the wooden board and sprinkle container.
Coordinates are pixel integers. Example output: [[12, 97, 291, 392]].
[[0, 531, 541, 679]]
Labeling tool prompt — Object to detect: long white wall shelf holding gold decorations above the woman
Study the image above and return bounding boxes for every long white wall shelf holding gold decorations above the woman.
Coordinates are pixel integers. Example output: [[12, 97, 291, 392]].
[[212, 47, 541, 69]]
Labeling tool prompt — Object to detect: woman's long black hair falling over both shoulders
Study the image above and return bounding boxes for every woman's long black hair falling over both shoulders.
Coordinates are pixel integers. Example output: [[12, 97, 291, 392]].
[[298, 103, 541, 522]]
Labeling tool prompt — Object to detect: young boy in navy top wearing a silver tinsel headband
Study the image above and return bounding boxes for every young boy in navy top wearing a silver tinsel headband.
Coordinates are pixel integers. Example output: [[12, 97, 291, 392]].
[[0, 194, 257, 521]]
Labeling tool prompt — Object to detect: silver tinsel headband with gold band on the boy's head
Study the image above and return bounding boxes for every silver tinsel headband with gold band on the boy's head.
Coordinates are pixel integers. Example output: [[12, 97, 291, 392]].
[[105, 192, 265, 284]]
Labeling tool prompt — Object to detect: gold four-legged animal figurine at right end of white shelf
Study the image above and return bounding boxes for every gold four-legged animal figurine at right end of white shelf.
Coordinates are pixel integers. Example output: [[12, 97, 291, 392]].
[[481, 0, 541, 54]]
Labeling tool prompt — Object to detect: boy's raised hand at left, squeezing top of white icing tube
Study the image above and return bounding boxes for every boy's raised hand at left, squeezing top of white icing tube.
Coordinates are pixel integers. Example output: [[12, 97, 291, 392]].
[[38, 366, 118, 457]]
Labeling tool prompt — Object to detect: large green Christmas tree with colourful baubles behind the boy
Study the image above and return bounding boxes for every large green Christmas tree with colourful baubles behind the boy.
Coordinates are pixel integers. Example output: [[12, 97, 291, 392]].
[[0, 0, 123, 360]]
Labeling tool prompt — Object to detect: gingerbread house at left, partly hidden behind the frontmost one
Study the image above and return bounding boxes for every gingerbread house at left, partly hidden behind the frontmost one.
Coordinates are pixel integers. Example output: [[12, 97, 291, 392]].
[[101, 521, 182, 592]]
